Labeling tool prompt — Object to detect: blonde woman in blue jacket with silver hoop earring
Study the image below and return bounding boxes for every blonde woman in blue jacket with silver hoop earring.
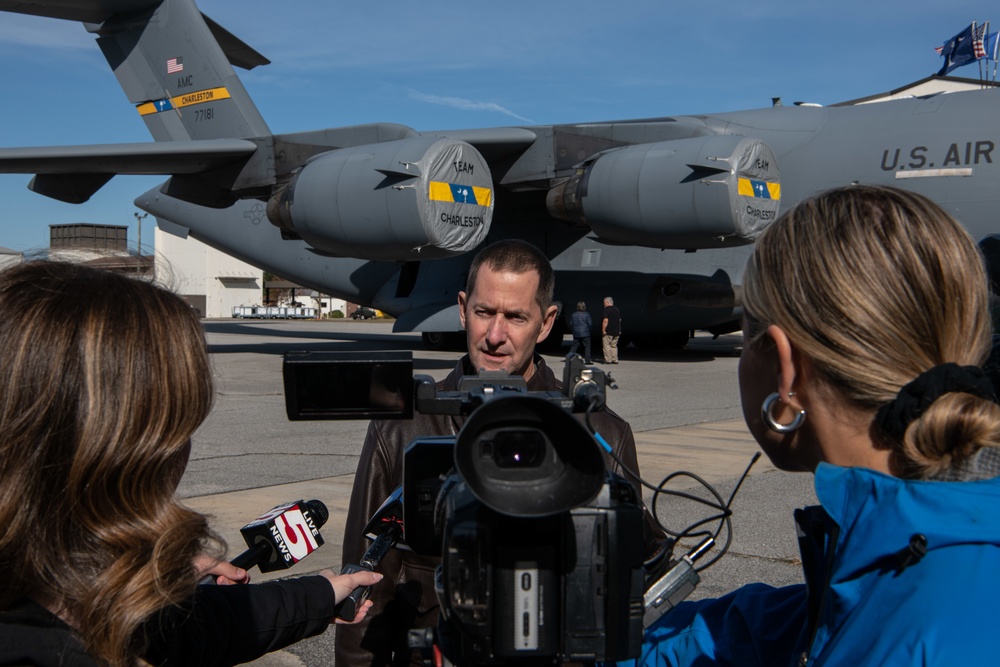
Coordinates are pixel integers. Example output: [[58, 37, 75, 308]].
[[628, 186, 1000, 667]]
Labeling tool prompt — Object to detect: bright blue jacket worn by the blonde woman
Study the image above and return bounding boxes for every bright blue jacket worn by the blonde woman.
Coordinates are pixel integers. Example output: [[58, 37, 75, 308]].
[[622, 464, 1000, 667]]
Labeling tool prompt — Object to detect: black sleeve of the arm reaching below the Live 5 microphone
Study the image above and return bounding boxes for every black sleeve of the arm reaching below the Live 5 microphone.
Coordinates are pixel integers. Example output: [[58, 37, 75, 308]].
[[144, 576, 336, 667]]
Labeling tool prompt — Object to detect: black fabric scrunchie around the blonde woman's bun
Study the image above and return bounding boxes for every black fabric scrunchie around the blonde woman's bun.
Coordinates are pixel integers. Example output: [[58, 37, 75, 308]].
[[875, 363, 996, 440]]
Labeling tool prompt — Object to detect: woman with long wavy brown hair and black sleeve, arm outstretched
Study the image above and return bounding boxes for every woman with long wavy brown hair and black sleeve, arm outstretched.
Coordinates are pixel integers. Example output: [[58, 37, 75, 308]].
[[0, 262, 378, 667]]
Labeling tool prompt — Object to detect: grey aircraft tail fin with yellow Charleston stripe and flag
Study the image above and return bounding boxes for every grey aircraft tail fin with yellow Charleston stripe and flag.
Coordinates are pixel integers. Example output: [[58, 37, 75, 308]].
[[89, 0, 270, 141]]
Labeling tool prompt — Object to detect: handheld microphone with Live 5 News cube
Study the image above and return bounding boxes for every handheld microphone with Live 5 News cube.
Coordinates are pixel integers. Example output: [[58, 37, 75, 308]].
[[198, 500, 330, 584]]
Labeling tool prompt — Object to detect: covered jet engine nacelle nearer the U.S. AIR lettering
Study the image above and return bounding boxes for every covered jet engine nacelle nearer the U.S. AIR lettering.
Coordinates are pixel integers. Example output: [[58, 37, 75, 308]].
[[546, 135, 781, 249]]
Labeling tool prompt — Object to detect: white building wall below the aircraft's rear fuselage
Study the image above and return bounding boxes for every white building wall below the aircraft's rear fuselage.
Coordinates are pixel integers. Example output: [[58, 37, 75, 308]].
[[155, 227, 264, 317]]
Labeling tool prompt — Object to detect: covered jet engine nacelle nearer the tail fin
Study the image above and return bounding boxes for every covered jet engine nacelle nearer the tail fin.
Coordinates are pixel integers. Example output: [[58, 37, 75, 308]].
[[267, 137, 493, 260]]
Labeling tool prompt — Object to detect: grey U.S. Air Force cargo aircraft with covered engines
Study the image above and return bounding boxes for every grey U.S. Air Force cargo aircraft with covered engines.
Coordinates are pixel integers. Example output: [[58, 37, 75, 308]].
[[0, 0, 1000, 347]]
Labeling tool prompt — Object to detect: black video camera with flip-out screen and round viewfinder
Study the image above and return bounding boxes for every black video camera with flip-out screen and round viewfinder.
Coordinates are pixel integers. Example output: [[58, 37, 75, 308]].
[[284, 352, 644, 665]]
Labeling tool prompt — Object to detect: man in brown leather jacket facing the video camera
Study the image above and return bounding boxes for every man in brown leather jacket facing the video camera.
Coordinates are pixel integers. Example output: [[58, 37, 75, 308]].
[[336, 240, 650, 667]]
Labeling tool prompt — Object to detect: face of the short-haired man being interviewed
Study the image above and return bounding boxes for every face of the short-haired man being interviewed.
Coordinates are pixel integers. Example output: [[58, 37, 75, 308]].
[[458, 265, 557, 379]]
